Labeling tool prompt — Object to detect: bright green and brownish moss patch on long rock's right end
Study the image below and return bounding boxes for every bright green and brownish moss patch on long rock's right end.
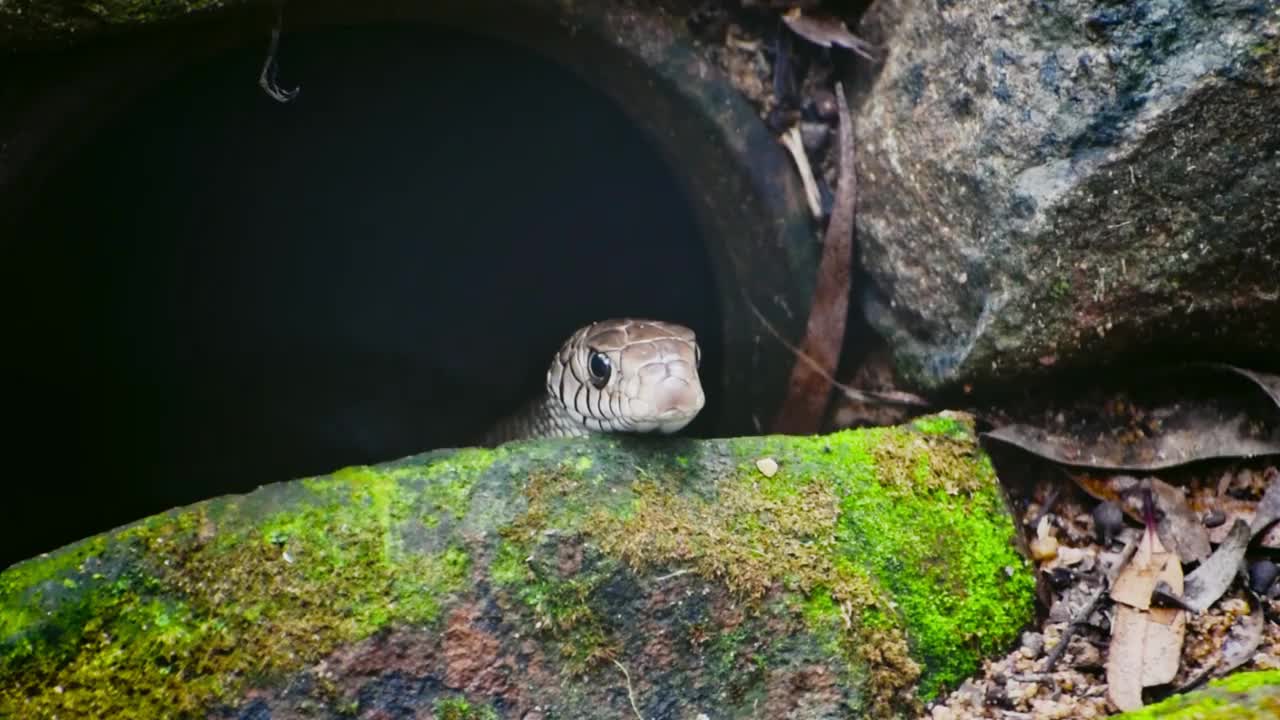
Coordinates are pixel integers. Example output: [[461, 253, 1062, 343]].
[[590, 418, 1034, 712]]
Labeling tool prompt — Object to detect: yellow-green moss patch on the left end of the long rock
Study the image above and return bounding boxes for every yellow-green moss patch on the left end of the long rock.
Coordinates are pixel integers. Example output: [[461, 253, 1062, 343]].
[[0, 456, 484, 720]]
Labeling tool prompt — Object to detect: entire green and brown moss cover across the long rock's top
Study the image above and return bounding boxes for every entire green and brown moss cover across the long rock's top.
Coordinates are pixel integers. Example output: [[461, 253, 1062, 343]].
[[0, 418, 1032, 720]]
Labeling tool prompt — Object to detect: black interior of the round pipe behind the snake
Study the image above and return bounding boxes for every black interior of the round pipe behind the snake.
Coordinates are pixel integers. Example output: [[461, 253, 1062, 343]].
[[0, 26, 721, 566]]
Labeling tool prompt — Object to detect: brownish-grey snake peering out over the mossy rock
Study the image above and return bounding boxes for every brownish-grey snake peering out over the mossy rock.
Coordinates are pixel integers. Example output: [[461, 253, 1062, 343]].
[[479, 318, 707, 447]]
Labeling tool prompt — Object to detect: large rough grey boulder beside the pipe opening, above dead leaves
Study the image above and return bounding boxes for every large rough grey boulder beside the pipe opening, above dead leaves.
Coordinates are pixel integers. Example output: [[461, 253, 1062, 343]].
[[858, 0, 1280, 387]]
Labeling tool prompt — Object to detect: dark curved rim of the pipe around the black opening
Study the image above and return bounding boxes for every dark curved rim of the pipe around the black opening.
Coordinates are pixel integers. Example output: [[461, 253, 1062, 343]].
[[0, 0, 819, 434]]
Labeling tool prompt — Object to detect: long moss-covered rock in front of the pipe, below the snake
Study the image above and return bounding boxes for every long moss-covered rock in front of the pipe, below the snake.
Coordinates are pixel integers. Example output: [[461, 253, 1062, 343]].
[[0, 416, 1033, 719]]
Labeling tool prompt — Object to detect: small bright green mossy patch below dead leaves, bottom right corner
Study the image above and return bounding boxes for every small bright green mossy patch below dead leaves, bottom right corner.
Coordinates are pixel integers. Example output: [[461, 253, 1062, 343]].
[[1116, 670, 1280, 720]]
